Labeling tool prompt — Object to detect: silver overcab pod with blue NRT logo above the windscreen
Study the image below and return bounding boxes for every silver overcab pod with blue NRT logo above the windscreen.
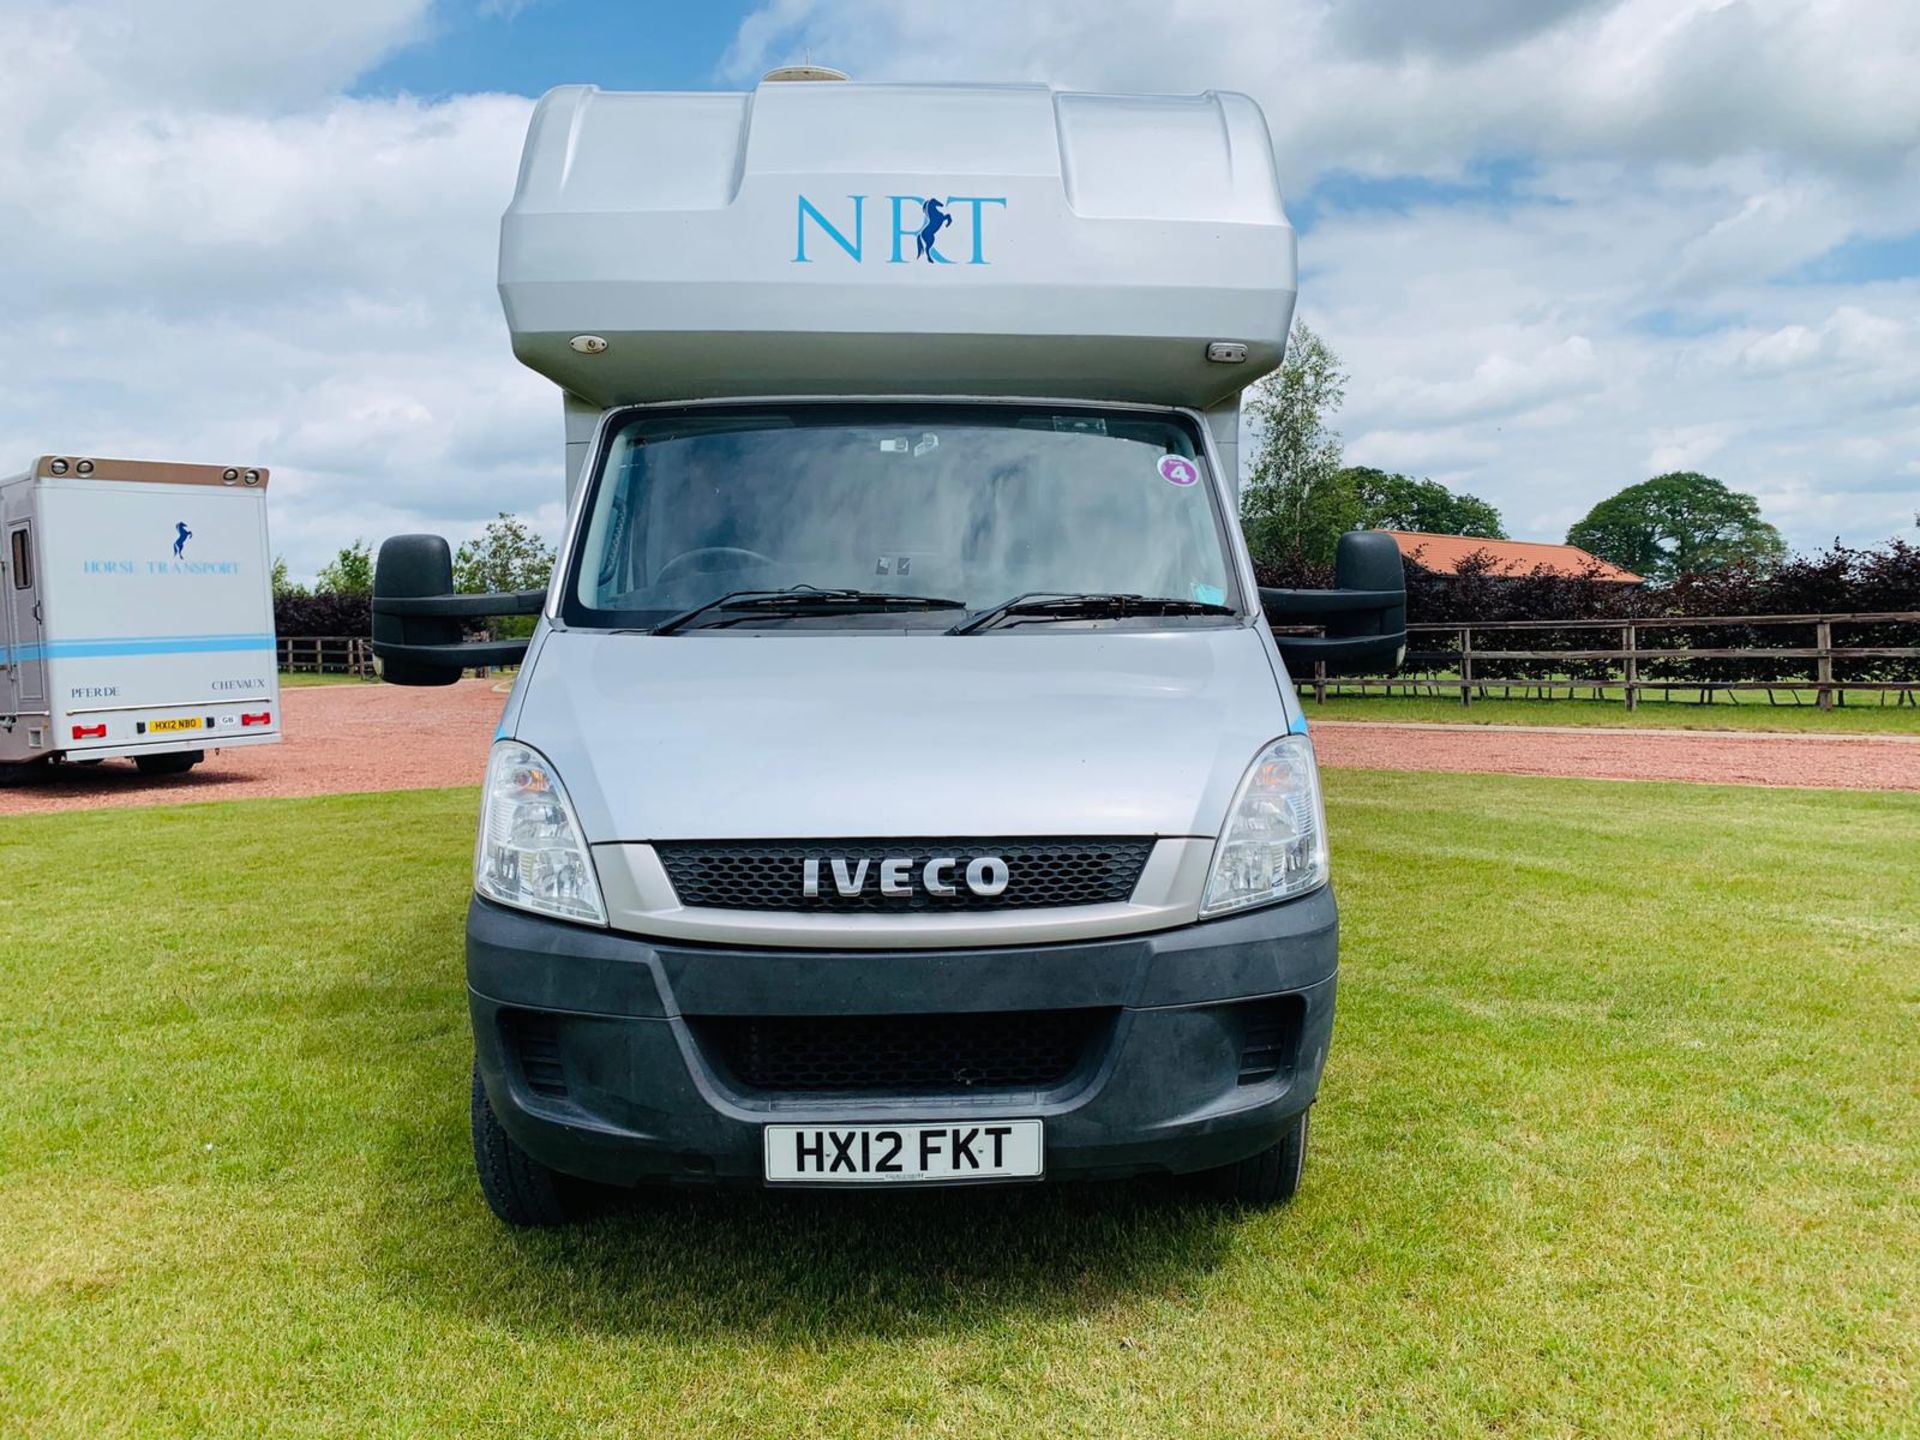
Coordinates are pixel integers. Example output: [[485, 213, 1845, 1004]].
[[499, 84, 1294, 503]]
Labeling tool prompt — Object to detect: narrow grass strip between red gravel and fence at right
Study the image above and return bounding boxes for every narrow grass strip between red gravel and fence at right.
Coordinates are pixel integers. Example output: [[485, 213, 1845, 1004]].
[[1300, 691, 1920, 735]]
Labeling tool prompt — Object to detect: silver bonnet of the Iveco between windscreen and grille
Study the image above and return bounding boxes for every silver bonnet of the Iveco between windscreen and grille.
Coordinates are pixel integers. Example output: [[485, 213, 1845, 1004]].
[[513, 624, 1290, 845]]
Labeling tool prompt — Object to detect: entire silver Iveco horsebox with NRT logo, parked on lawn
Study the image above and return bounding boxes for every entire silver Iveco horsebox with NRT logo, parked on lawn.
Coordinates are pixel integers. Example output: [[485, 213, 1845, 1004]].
[[374, 83, 1405, 1225]]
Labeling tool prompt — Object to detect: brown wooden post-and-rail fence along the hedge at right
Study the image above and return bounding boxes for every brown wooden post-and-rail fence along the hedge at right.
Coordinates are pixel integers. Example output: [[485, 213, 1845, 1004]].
[[1300, 611, 1920, 710]]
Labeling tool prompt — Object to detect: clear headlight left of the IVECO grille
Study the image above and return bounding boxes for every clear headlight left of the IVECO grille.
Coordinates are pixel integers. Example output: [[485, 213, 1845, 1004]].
[[474, 739, 607, 925]]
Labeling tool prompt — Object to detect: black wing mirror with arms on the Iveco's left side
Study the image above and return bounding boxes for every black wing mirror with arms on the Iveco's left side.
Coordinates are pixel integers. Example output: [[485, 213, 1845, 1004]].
[[372, 536, 547, 685]]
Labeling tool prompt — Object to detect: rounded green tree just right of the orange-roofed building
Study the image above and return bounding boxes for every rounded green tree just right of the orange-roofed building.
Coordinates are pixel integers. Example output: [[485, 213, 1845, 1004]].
[[1567, 470, 1788, 580]]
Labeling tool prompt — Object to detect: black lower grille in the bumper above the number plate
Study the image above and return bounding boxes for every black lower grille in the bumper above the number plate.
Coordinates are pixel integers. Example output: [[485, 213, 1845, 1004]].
[[693, 1010, 1114, 1094]]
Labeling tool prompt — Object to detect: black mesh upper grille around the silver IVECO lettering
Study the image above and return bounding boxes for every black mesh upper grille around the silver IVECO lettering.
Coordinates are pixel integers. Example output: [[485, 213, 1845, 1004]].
[[655, 839, 1154, 914]]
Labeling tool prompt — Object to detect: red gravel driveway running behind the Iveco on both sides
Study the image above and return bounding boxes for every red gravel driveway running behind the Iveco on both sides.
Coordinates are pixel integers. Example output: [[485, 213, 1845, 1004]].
[[0, 680, 1920, 816]]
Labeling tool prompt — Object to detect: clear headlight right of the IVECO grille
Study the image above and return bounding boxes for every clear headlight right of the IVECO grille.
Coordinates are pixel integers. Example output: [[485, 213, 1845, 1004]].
[[1200, 735, 1327, 916]]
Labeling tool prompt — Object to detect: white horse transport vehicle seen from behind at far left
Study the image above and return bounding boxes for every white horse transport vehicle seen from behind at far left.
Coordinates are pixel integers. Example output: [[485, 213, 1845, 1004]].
[[0, 455, 280, 774]]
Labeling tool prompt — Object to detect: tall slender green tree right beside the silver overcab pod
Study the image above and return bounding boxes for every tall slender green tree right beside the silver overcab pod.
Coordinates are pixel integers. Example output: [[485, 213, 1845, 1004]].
[[1240, 321, 1359, 563]]
